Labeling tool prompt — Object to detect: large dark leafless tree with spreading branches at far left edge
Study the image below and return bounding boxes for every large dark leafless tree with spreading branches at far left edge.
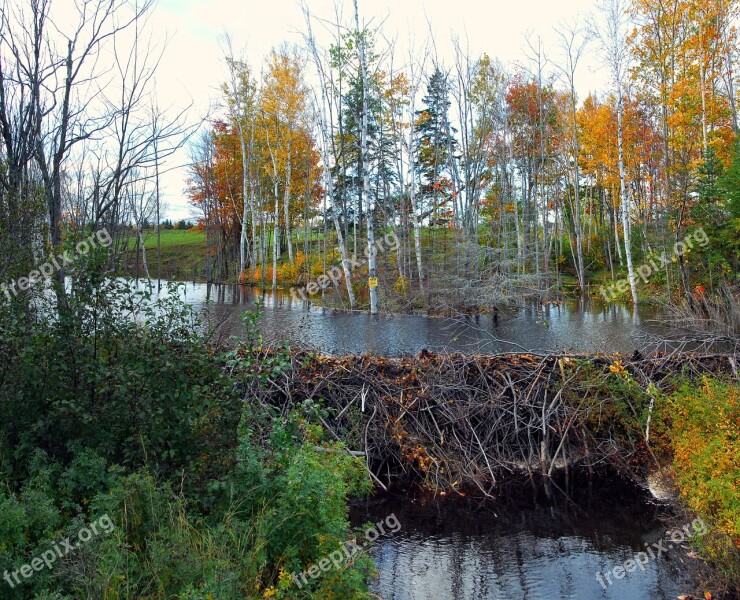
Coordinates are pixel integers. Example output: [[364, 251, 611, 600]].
[[0, 0, 153, 248]]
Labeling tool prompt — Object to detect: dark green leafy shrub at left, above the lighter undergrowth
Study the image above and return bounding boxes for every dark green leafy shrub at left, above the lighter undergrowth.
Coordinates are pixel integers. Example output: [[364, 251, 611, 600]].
[[0, 280, 240, 499]]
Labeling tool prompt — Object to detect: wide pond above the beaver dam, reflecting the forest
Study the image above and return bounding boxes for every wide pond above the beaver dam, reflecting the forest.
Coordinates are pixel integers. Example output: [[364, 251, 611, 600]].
[[145, 283, 666, 356]]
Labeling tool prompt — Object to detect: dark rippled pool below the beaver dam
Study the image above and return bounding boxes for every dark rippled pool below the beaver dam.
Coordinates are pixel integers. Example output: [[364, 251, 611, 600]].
[[352, 486, 694, 600]]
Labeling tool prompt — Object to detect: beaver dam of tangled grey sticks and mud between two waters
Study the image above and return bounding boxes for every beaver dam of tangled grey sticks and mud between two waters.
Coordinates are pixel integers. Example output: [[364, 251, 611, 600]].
[[238, 351, 738, 495]]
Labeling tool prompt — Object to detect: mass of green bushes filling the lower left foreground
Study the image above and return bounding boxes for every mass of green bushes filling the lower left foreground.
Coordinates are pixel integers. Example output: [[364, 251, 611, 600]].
[[0, 254, 371, 600]]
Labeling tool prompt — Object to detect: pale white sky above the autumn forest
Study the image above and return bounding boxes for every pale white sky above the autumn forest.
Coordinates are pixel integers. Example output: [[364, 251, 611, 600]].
[[149, 0, 607, 220]]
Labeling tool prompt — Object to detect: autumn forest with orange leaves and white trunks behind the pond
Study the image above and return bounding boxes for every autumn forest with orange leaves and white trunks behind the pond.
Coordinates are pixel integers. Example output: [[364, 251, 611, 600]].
[[176, 0, 740, 312]]
